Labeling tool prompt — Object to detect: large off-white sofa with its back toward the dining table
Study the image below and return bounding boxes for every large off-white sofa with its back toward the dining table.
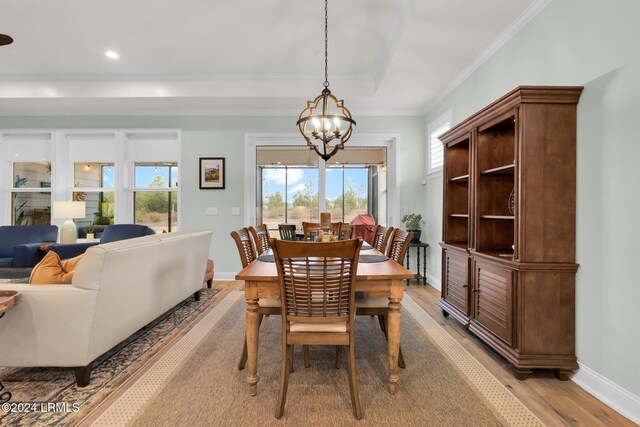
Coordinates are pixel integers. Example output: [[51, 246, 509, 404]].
[[0, 230, 212, 386]]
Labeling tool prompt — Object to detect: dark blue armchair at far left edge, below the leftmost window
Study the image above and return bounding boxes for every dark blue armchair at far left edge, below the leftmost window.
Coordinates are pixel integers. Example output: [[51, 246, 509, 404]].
[[0, 225, 58, 268]]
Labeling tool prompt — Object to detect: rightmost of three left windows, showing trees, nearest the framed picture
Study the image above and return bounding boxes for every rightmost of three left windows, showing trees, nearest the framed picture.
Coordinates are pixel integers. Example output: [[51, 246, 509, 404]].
[[133, 162, 178, 233]]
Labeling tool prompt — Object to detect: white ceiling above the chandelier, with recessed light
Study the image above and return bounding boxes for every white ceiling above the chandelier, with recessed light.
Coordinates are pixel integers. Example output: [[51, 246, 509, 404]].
[[0, 0, 548, 118]]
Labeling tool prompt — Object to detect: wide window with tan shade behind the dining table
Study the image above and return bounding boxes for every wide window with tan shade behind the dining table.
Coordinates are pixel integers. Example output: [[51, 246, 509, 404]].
[[256, 145, 387, 234]]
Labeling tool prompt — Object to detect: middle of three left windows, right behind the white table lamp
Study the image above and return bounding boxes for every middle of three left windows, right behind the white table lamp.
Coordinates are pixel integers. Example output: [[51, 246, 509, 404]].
[[73, 162, 116, 232]]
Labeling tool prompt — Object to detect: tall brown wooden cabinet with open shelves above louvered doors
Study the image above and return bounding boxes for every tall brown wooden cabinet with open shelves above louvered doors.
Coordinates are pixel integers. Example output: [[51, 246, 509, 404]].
[[440, 86, 582, 379]]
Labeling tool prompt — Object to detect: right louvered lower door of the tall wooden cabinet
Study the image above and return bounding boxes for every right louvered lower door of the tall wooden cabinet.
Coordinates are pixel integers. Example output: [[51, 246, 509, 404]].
[[473, 260, 513, 345]]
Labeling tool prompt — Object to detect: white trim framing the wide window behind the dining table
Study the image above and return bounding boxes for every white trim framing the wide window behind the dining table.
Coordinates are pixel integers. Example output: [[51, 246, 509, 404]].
[[244, 133, 400, 227]]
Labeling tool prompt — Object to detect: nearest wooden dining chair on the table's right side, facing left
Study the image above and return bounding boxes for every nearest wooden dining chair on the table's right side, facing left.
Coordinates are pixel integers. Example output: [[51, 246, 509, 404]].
[[356, 226, 413, 368]]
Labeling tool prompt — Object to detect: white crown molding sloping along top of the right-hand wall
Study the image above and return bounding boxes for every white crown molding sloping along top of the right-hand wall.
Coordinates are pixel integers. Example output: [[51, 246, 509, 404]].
[[424, 0, 552, 115]]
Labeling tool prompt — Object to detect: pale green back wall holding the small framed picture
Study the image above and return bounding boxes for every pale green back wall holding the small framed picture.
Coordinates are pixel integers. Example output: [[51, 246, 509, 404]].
[[0, 116, 424, 272]]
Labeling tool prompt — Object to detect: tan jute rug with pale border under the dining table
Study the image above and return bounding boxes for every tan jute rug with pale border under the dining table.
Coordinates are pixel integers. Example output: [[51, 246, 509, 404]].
[[133, 297, 541, 427]]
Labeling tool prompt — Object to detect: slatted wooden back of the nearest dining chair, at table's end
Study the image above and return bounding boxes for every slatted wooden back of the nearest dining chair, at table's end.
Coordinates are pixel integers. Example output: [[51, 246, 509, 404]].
[[273, 240, 362, 323]]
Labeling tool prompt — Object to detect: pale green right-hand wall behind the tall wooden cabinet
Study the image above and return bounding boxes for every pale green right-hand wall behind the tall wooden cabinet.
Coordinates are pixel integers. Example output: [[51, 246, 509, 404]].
[[426, 0, 640, 396]]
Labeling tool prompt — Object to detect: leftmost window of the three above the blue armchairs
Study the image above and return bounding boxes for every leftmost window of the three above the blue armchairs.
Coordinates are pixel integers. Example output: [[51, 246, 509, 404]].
[[11, 161, 51, 225]]
